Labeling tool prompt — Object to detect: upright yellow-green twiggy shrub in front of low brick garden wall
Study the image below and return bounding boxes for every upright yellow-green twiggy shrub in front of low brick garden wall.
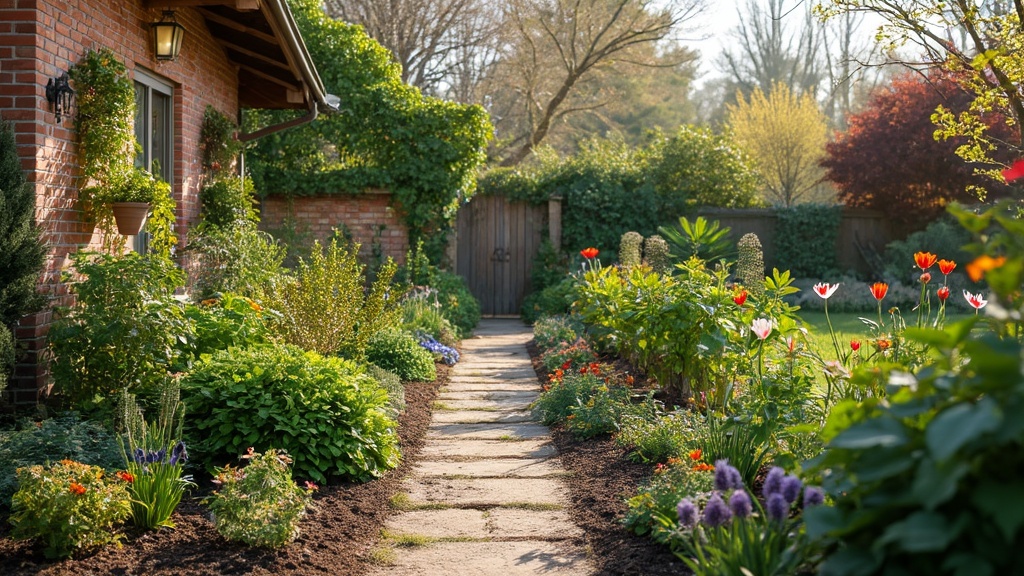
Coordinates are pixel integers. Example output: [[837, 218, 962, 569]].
[[271, 240, 399, 354]]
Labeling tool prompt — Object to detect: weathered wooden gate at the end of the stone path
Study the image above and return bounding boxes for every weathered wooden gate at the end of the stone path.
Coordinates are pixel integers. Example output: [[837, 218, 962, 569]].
[[455, 196, 548, 316]]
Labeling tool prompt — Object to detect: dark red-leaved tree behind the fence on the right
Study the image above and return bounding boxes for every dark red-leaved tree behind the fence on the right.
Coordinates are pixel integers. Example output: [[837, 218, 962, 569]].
[[821, 70, 1015, 228]]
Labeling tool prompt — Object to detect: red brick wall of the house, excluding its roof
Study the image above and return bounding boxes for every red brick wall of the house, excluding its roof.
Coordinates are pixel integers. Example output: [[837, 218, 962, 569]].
[[0, 0, 238, 403]]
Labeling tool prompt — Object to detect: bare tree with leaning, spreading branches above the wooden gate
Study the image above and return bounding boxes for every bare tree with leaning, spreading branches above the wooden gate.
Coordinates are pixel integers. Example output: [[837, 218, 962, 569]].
[[488, 0, 706, 165]]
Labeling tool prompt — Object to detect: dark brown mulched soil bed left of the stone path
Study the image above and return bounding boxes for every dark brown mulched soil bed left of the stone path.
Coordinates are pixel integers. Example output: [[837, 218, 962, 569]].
[[0, 365, 449, 576]]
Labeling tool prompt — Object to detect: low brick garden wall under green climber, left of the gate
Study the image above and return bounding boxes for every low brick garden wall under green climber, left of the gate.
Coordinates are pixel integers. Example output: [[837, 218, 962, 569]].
[[260, 191, 409, 264]]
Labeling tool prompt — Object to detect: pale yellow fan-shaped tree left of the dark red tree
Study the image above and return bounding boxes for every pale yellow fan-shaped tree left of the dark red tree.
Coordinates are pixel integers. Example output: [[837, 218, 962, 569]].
[[728, 82, 829, 207]]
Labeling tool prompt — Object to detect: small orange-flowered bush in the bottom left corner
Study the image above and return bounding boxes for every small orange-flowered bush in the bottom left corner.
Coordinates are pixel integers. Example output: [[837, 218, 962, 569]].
[[10, 460, 131, 559]]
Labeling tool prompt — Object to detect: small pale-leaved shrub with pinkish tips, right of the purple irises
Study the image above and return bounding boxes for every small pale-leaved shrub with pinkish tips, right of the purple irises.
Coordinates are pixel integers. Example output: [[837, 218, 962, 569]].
[[209, 448, 316, 548]]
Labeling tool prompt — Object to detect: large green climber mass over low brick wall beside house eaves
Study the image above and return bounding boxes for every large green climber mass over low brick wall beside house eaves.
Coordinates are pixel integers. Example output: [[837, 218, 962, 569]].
[[244, 0, 493, 262]]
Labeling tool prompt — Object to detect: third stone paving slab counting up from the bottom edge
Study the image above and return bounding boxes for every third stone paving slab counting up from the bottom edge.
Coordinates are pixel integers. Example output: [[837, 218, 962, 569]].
[[401, 478, 568, 507]]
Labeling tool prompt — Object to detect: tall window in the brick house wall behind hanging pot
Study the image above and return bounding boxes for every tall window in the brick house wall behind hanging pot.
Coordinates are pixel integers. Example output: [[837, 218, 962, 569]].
[[133, 69, 174, 253]]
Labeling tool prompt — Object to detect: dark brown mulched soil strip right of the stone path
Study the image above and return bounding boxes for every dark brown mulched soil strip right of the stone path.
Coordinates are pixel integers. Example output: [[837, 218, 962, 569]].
[[527, 342, 690, 576]]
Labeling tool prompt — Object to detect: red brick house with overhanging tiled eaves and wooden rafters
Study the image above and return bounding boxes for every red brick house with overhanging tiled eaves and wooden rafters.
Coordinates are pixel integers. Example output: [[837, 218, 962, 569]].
[[0, 0, 331, 404]]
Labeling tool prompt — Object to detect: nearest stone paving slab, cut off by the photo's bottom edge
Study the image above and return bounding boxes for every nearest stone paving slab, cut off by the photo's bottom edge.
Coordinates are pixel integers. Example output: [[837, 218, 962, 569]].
[[370, 540, 590, 576]]
